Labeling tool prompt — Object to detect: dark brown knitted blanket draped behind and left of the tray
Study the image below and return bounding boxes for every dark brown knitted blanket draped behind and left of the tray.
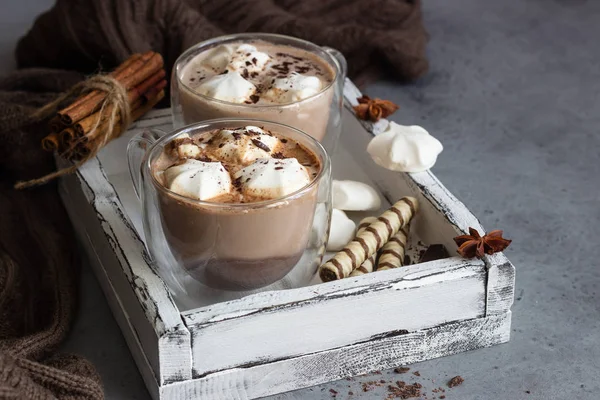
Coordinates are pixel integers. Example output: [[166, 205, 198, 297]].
[[0, 0, 427, 399]]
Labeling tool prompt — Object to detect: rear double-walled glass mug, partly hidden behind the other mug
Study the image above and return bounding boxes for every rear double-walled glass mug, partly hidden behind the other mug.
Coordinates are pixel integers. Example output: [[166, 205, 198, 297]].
[[171, 33, 347, 154]]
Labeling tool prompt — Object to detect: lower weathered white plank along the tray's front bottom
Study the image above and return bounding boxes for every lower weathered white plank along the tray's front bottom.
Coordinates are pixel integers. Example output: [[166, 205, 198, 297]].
[[160, 311, 511, 400]]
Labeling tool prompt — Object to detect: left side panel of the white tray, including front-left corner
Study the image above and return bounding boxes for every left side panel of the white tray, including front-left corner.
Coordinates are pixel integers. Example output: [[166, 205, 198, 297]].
[[59, 159, 191, 384]]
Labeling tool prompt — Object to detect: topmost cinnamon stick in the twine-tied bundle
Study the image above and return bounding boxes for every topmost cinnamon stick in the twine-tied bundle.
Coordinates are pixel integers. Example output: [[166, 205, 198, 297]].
[[59, 52, 164, 125]]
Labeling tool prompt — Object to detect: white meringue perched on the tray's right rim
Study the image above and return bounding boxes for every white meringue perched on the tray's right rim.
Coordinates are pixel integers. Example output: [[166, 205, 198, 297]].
[[367, 122, 444, 172]]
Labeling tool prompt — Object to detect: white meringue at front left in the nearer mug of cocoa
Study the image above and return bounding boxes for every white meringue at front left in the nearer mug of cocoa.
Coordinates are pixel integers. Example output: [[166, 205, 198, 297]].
[[163, 159, 232, 200]]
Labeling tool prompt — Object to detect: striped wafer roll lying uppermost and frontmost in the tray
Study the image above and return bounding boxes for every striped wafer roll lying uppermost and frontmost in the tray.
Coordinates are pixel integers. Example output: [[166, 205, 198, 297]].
[[319, 197, 419, 282]]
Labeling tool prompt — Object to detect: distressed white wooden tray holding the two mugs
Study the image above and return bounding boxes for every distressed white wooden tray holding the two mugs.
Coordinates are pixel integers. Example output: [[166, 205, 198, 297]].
[[61, 81, 515, 399]]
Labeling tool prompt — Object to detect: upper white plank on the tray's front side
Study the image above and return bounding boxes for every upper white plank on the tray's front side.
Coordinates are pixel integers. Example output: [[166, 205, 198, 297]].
[[186, 262, 486, 377]]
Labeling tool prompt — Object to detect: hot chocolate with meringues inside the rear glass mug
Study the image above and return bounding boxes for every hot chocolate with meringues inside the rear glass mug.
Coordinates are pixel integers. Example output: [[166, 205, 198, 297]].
[[178, 40, 336, 141]]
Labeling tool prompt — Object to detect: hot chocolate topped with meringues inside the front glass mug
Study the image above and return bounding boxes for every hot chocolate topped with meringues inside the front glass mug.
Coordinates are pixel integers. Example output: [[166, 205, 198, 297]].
[[152, 126, 322, 290]]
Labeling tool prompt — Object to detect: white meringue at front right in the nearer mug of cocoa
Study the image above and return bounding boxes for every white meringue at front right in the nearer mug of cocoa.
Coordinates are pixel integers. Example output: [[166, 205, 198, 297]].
[[234, 158, 311, 199]]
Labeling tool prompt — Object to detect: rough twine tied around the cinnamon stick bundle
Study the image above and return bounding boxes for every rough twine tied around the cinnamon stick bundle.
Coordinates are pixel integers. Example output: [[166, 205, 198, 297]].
[[15, 75, 131, 189]]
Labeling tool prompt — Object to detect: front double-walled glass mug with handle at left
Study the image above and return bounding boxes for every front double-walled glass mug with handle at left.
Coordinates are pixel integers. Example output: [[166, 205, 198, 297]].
[[127, 119, 331, 293]]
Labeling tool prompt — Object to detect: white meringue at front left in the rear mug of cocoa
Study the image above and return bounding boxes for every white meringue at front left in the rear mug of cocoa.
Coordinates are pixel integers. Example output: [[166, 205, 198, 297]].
[[196, 71, 256, 103]]
